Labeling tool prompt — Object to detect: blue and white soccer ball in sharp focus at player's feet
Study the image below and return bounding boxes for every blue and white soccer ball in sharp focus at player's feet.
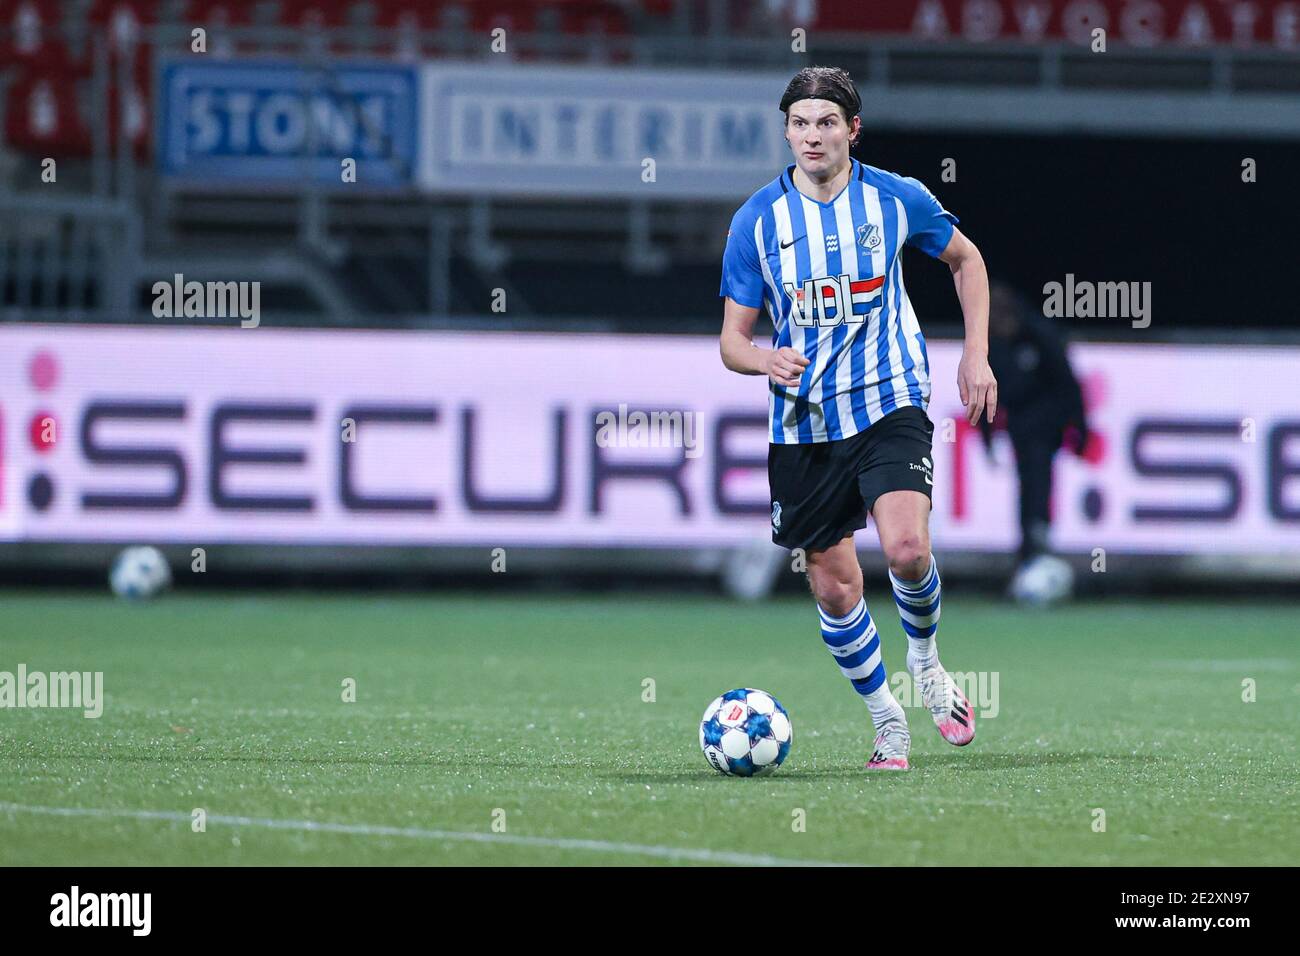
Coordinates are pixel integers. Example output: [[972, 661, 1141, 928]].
[[699, 687, 794, 777]]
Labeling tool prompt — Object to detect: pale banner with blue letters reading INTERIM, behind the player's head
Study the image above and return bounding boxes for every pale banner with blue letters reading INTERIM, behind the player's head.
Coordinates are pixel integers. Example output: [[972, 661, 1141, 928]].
[[420, 64, 790, 199]]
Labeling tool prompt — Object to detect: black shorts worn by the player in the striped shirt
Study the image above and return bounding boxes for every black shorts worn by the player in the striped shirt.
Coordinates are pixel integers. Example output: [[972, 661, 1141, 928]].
[[767, 405, 935, 551]]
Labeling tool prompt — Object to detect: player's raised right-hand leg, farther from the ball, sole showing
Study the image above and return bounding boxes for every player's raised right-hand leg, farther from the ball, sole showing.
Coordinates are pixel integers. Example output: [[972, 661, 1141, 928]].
[[871, 489, 975, 747]]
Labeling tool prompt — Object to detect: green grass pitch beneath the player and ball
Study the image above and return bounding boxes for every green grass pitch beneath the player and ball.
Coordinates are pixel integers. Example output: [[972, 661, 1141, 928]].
[[0, 589, 1300, 866]]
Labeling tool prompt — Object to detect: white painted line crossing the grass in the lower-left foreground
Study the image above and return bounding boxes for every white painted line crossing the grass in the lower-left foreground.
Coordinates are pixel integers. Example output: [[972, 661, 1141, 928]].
[[0, 803, 853, 866]]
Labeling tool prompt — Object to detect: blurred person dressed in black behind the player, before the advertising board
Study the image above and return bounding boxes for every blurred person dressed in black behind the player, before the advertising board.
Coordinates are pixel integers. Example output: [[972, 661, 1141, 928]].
[[979, 281, 1088, 602]]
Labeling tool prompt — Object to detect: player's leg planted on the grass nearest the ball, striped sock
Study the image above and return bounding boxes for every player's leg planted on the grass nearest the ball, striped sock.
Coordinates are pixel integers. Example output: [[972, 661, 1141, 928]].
[[807, 535, 911, 770]]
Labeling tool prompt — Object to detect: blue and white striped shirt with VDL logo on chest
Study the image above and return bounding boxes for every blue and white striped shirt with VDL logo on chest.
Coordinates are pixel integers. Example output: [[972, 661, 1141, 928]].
[[719, 160, 958, 445]]
